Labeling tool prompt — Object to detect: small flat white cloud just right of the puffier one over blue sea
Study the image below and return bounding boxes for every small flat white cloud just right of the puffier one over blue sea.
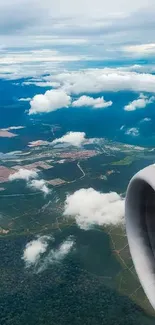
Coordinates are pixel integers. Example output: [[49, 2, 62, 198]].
[[72, 95, 113, 108]]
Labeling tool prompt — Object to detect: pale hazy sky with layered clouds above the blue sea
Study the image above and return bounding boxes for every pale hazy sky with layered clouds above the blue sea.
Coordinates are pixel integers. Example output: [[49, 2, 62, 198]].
[[0, 0, 155, 79]]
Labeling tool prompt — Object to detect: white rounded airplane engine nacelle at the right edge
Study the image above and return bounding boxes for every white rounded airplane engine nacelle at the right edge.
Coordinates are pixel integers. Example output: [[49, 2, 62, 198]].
[[125, 165, 155, 309]]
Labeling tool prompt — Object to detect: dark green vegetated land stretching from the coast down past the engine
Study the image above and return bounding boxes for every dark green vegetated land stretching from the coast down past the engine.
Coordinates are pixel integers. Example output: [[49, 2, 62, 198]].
[[0, 141, 154, 325]]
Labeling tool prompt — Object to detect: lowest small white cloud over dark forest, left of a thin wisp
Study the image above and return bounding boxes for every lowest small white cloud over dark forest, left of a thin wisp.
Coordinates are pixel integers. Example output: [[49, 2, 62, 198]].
[[22, 236, 48, 267]]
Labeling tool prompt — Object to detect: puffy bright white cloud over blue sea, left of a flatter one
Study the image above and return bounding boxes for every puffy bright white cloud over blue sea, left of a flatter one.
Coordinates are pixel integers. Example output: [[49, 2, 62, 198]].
[[29, 89, 71, 115]]
